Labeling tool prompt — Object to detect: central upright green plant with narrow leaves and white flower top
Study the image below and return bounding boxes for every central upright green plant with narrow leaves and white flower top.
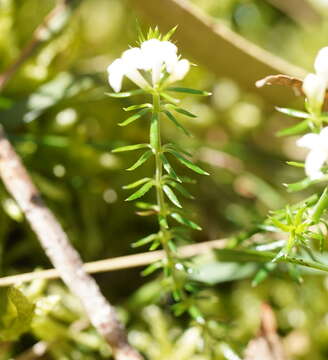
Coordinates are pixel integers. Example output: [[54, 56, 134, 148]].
[[108, 28, 209, 318]]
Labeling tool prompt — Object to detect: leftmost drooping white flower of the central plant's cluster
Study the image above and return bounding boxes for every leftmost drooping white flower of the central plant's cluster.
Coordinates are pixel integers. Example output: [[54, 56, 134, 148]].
[[107, 48, 149, 92]]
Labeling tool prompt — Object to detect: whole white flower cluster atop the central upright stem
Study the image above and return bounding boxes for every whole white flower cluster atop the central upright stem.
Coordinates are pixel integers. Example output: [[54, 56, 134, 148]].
[[107, 39, 190, 92]]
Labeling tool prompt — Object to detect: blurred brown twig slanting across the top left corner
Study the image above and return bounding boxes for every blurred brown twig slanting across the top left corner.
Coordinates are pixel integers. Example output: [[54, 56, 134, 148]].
[[0, 0, 69, 91]]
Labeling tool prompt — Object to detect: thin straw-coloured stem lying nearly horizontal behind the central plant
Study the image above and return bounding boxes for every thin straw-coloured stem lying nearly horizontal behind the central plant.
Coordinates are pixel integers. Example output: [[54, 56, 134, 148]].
[[0, 239, 226, 287]]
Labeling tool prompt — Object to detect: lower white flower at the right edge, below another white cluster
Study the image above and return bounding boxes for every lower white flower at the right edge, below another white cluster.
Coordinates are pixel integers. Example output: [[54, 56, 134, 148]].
[[297, 127, 328, 180]]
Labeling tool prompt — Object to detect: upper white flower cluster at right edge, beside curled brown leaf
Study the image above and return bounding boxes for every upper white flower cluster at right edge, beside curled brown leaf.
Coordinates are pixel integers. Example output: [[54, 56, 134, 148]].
[[303, 47, 328, 114]]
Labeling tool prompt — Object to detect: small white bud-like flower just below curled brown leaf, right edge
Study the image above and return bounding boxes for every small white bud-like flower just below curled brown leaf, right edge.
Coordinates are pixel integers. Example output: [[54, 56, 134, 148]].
[[303, 74, 326, 112]]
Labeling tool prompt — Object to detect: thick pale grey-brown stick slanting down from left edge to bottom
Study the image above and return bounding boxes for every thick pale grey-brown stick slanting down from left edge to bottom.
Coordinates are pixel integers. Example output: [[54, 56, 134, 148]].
[[0, 127, 142, 360]]
